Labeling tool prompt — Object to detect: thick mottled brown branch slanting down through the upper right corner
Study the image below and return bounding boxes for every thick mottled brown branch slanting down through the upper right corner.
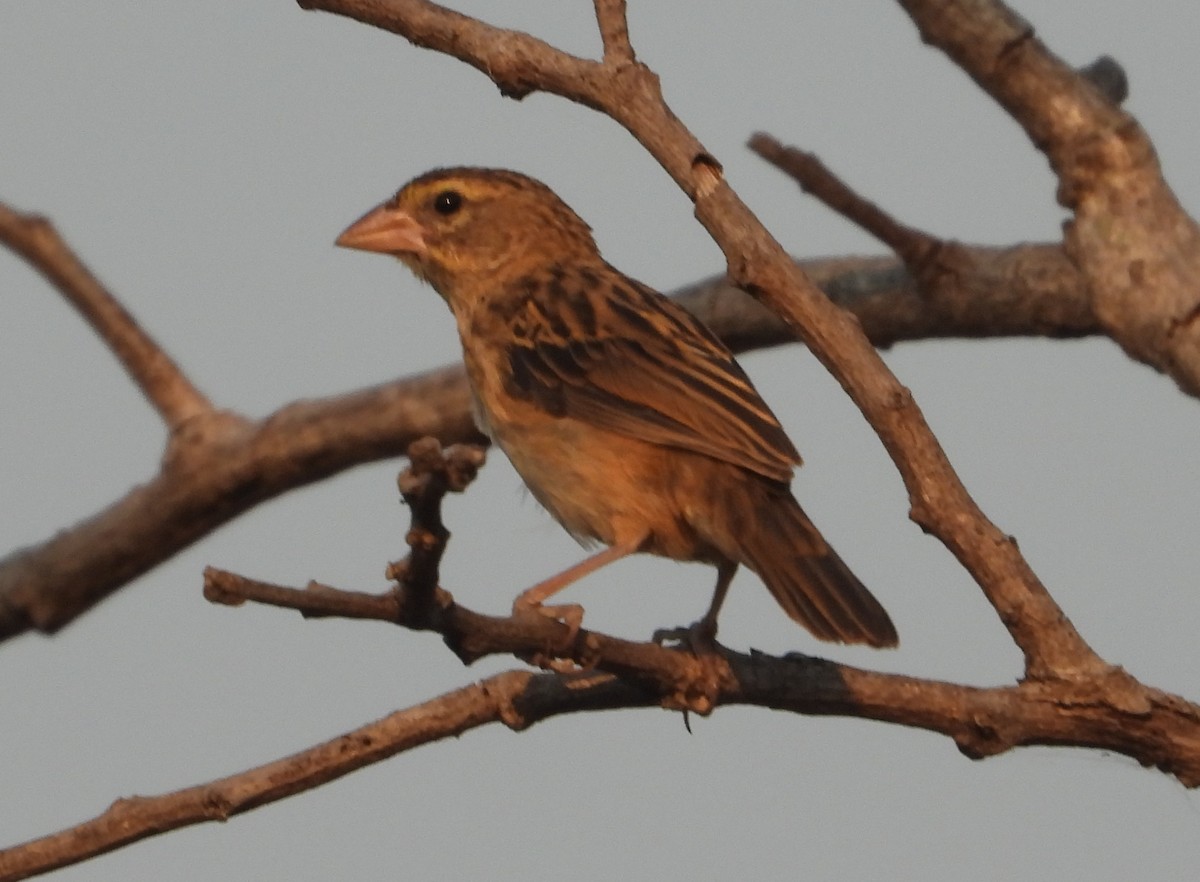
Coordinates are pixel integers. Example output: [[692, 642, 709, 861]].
[[900, 0, 1200, 396]]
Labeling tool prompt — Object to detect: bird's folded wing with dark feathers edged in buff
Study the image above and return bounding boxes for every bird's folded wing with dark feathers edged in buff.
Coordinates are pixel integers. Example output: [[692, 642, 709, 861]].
[[508, 265, 800, 481]]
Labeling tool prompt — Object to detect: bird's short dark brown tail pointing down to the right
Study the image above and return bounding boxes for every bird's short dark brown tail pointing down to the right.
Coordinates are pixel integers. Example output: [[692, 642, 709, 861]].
[[736, 481, 899, 647]]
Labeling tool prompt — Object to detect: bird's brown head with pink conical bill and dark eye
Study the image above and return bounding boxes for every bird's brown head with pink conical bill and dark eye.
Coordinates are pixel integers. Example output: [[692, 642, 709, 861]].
[[337, 168, 596, 307]]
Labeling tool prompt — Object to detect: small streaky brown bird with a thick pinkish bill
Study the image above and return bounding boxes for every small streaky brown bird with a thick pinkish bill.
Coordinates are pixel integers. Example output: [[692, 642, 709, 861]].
[[336, 167, 898, 647]]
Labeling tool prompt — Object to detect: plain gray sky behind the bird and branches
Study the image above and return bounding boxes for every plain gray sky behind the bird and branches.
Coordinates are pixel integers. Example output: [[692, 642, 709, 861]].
[[0, 0, 1200, 880]]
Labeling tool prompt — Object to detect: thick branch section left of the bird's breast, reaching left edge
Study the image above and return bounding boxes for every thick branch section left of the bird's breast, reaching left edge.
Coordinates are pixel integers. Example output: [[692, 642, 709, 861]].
[[0, 368, 479, 637]]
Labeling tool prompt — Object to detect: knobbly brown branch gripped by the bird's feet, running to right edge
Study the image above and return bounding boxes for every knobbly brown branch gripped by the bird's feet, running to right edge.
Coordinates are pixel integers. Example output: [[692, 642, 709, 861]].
[[205, 569, 1200, 787]]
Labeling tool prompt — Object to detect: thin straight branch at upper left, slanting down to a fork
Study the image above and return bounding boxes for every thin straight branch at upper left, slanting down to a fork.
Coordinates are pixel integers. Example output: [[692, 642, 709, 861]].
[[0, 204, 212, 431]]
